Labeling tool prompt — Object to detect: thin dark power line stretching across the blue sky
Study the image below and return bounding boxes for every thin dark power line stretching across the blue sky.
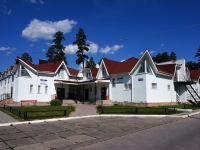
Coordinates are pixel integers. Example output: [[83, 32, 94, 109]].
[[2, 24, 200, 55]]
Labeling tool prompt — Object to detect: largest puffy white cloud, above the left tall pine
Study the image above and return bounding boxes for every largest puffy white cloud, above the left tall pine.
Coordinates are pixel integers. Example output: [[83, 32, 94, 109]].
[[22, 19, 77, 41]]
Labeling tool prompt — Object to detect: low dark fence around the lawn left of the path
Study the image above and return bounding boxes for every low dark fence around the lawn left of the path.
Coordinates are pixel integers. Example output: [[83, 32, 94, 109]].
[[3, 105, 67, 120]]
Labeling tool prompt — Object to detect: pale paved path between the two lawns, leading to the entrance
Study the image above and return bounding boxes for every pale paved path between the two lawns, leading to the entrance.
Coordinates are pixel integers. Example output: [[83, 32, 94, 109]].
[[70, 104, 98, 117]]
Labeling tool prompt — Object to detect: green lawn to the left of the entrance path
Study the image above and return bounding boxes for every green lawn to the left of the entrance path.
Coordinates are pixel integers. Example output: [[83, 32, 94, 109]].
[[2, 106, 75, 121]]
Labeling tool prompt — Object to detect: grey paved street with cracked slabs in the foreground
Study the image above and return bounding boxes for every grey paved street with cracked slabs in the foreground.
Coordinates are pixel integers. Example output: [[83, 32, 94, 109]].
[[0, 115, 200, 150]]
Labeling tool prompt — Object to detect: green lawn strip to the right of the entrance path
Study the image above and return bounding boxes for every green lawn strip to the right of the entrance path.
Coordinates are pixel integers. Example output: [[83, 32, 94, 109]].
[[97, 104, 200, 115]]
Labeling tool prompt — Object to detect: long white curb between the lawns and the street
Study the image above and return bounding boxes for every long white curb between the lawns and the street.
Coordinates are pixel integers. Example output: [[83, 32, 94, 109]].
[[0, 111, 200, 127]]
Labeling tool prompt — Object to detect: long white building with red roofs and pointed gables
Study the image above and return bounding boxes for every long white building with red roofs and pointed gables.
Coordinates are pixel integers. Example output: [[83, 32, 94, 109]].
[[0, 50, 200, 106]]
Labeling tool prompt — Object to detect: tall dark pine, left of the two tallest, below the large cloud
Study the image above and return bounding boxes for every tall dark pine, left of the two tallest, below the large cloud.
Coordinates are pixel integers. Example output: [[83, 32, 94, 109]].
[[46, 31, 68, 65]]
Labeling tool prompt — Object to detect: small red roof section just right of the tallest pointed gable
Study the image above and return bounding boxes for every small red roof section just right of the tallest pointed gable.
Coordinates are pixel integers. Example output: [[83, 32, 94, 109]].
[[156, 64, 176, 75]]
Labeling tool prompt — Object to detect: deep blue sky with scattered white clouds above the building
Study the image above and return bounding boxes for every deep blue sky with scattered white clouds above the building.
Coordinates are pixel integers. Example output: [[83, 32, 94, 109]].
[[0, 0, 200, 71]]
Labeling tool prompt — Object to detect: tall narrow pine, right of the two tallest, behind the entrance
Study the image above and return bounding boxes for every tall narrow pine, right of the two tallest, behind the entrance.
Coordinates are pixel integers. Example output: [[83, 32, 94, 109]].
[[73, 28, 90, 69]]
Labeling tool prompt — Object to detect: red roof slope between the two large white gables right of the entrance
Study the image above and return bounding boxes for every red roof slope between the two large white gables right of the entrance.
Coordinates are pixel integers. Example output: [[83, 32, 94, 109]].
[[110, 57, 139, 74]]
